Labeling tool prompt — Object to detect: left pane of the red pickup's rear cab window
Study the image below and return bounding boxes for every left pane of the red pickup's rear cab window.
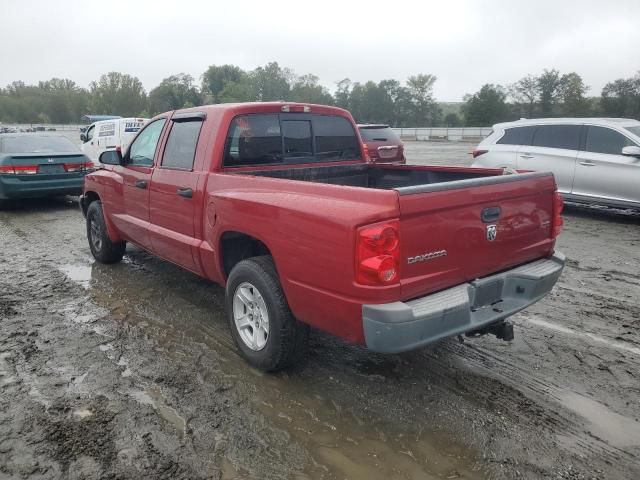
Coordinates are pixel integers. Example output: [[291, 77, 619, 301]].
[[224, 115, 282, 166]]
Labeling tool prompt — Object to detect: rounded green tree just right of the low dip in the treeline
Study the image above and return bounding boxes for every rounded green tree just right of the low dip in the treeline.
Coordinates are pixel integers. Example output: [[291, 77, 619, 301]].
[[462, 83, 509, 127]]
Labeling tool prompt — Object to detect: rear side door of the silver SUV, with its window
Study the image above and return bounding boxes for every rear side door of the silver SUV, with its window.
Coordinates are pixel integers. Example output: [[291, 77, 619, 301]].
[[518, 124, 582, 197]]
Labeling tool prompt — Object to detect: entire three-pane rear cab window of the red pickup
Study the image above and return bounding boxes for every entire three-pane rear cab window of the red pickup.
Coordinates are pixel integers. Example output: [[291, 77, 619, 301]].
[[223, 113, 361, 167]]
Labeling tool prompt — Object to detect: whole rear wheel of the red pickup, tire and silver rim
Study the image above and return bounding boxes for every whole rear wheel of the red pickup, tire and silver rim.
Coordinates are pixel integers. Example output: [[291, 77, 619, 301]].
[[226, 256, 309, 372]]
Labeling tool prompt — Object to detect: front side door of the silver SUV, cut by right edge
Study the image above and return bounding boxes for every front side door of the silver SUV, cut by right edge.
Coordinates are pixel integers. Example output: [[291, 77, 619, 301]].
[[572, 125, 640, 204]]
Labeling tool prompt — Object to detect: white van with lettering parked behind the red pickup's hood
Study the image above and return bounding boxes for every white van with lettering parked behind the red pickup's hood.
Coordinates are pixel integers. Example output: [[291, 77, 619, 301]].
[[80, 118, 149, 165]]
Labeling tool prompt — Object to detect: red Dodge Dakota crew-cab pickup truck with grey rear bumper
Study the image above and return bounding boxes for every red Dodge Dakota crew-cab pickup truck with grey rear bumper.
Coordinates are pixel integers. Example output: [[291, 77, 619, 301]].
[[80, 102, 564, 371]]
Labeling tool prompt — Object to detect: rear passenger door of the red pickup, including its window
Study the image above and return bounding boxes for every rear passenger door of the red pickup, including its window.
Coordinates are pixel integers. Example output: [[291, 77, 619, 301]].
[[149, 112, 207, 273]]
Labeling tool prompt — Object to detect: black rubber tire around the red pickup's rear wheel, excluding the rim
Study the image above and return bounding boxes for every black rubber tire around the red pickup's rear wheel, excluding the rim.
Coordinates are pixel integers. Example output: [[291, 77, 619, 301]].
[[225, 256, 309, 372]]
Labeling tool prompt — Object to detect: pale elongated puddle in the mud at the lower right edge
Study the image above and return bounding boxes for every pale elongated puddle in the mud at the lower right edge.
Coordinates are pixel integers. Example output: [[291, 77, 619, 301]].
[[558, 392, 640, 448]]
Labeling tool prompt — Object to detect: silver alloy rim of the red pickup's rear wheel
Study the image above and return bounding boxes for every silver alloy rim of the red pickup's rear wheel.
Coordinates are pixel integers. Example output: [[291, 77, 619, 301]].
[[233, 282, 269, 352]]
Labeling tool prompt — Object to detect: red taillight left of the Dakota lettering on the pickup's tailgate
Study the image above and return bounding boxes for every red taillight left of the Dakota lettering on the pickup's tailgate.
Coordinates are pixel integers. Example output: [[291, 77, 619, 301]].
[[356, 220, 400, 285]]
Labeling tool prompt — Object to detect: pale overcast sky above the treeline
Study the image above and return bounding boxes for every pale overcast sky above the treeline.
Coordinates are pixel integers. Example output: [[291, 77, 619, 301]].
[[0, 0, 640, 101]]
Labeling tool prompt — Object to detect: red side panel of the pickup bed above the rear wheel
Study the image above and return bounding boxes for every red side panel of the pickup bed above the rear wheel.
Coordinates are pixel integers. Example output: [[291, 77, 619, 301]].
[[201, 174, 400, 341]]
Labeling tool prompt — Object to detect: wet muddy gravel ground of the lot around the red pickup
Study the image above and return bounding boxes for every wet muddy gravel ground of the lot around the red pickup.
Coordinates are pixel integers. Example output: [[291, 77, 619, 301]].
[[0, 144, 640, 479]]
